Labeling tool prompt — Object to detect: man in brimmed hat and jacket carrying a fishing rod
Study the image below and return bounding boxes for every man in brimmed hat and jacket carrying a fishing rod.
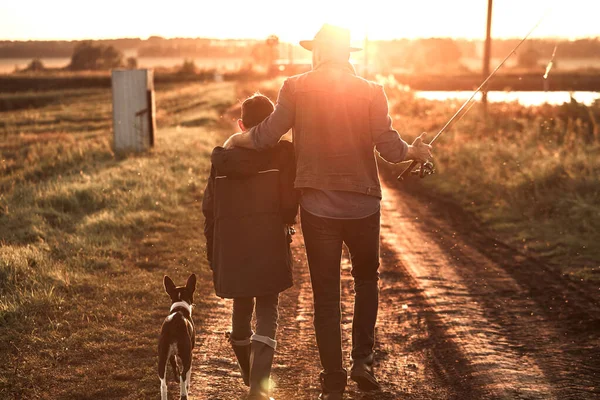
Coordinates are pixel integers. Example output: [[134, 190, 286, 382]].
[[224, 25, 431, 400]]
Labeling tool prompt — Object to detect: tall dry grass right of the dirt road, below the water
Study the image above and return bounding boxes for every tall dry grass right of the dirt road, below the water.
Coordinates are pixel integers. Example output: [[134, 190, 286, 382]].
[[387, 77, 600, 280]]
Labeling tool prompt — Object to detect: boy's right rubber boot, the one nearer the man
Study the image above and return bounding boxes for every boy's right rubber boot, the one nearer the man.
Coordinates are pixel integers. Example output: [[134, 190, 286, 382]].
[[247, 335, 276, 400]]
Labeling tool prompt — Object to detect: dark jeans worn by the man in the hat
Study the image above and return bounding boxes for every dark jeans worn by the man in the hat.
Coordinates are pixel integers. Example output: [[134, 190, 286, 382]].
[[301, 209, 380, 391]]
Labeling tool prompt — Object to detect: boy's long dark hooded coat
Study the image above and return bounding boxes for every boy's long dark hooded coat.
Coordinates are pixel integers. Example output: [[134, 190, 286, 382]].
[[202, 141, 298, 298]]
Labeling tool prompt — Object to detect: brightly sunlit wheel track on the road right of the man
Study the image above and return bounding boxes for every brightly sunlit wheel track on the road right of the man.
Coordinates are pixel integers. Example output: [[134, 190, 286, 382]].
[[382, 182, 556, 399]]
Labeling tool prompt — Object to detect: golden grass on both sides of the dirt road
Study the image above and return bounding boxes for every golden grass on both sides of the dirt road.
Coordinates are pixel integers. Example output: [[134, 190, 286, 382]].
[[0, 76, 600, 399]]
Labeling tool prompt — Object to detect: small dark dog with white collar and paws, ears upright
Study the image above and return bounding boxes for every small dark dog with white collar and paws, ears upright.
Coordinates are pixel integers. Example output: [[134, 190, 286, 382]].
[[158, 274, 196, 400]]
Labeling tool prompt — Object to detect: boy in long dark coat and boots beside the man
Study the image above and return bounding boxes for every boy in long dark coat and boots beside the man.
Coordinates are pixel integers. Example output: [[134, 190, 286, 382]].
[[202, 94, 298, 400]]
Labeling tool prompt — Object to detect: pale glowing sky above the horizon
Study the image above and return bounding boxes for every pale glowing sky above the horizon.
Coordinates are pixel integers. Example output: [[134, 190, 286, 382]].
[[0, 0, 600, 41]]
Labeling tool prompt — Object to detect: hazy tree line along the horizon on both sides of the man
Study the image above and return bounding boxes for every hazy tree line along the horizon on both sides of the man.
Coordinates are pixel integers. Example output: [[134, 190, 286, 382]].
[[5, 35, 600, 73]]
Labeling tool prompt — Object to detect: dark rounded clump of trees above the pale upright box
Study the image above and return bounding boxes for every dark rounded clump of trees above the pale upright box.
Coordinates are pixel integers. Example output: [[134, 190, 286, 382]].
[[69, 41, 123, 71]]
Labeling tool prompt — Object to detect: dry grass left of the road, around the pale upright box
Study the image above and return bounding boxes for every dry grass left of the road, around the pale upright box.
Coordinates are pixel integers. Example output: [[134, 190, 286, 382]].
[[0, 80, 235, 399]]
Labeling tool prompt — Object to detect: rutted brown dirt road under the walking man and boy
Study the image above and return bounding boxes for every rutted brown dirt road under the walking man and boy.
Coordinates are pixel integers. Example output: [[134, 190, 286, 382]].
[[192, 174, 600, 400]]
